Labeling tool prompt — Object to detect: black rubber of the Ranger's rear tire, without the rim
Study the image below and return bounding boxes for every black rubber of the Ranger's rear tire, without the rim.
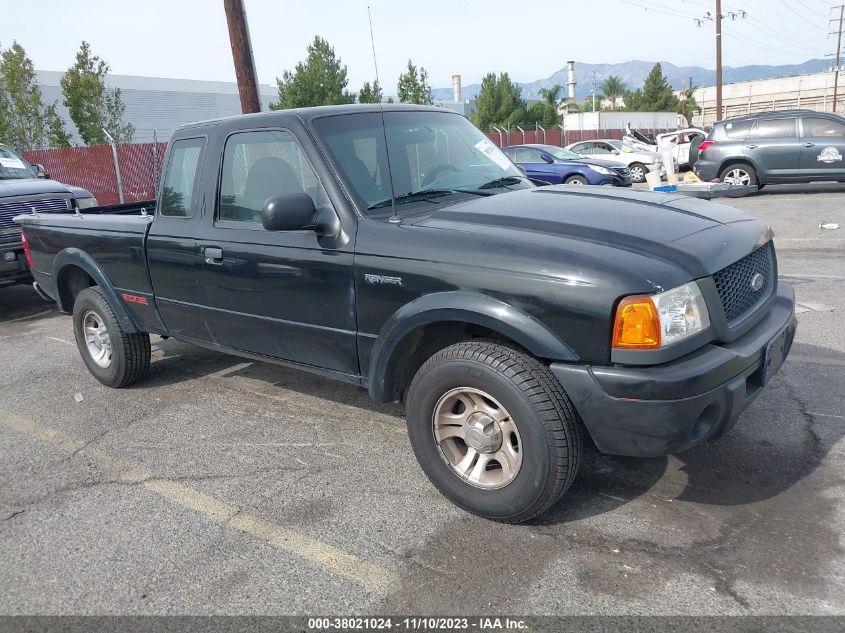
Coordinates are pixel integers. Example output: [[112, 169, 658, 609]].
[[73, 286, 150, 388]]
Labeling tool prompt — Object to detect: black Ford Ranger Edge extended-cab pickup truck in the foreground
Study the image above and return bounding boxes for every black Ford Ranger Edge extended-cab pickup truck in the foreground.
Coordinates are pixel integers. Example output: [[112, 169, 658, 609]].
[[16, 105, 796, 523]]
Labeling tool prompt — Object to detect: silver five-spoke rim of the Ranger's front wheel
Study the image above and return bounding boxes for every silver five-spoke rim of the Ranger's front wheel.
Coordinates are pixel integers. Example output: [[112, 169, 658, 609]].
[[432, 387, 522, 490]]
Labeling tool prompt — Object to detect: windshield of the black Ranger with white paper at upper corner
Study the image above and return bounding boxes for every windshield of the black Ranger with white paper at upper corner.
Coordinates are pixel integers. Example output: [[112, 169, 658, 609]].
[[314, 111, 533, 214]]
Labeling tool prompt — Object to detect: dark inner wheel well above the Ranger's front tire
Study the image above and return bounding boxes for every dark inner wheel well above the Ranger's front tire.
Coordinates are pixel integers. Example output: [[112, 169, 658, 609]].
[[380, 321, 524, 401]]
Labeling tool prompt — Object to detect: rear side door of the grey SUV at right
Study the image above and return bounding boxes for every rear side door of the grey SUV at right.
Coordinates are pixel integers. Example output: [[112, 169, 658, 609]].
[[744, 117, 801, 182]]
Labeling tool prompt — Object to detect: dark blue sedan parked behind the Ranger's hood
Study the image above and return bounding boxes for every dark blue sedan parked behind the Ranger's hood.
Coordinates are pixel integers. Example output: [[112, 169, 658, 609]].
[[502, 145, 631, 187]]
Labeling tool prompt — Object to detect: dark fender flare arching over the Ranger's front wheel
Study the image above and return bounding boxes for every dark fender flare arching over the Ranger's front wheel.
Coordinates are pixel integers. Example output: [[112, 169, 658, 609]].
[[367, 291, 578, 402]]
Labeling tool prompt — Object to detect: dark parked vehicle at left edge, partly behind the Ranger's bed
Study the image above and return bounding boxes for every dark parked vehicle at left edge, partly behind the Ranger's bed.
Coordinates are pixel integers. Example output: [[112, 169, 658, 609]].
[[0, 145, 97, 287]]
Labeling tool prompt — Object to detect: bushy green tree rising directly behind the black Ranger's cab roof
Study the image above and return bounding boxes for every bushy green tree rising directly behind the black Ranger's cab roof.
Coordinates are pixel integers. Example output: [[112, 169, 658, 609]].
[[270, 35, 355, 110]]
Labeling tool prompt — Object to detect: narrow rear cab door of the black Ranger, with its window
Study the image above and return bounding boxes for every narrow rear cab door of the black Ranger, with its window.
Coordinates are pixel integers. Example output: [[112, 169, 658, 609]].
[[147, 137, 209, 340]]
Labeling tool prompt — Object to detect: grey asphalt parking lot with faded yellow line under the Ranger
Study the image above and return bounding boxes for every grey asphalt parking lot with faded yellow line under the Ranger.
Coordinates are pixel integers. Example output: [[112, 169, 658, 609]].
[[0, 185, 845, 615]]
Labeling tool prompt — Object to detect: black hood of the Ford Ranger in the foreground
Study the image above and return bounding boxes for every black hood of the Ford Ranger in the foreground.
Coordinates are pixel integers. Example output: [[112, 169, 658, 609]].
[[414, 185, 771, 278]]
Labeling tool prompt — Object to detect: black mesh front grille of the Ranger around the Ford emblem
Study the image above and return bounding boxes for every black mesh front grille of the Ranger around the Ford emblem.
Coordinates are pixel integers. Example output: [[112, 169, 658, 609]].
[[713, 241, 775, 325]]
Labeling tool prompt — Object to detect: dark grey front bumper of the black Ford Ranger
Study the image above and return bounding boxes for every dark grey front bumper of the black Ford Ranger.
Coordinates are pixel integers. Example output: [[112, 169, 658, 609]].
[[551, 284, 797, 457]]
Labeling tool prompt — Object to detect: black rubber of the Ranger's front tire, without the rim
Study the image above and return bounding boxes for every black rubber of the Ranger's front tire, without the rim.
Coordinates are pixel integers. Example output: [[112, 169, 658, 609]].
[[407, 339, 582, 523]]
